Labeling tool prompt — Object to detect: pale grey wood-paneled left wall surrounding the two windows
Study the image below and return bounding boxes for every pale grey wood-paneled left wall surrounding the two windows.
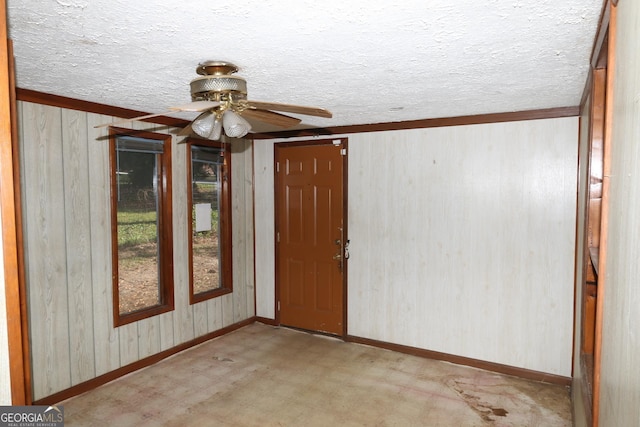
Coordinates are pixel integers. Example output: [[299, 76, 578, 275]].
[[18, 102, 254, 400]]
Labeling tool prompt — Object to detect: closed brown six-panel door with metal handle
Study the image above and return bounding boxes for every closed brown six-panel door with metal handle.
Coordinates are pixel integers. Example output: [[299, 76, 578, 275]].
[[275, 140, 346, 335]]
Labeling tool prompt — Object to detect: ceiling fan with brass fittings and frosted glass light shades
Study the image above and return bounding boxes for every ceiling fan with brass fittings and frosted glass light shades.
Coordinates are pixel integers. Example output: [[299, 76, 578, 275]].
[[96, 61, 332, 141]]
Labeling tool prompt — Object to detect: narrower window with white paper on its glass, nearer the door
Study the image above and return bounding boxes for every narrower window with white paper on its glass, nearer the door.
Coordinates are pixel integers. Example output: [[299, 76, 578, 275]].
[[187, 140, 232, 304]]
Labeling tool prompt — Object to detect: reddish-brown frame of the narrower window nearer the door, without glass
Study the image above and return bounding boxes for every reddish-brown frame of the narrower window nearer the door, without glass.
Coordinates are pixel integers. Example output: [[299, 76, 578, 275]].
[[186, 138, 233, 305]]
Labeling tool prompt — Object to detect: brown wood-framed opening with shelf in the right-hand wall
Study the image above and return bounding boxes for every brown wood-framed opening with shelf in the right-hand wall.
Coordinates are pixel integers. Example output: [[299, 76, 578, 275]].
[[573, 0, 616, 427]]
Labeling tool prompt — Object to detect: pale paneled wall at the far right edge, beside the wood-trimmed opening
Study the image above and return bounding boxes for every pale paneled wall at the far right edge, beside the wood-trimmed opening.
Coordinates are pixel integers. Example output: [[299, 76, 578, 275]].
[[596, 1, 640, 427]]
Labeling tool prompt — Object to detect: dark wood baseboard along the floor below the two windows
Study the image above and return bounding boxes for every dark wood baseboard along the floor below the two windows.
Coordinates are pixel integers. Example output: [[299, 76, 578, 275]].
[[33, 317, 255, 405]]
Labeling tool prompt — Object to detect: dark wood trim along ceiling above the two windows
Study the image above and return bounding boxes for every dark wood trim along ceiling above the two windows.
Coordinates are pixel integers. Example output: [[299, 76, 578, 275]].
[[16, 88, 190, 128]]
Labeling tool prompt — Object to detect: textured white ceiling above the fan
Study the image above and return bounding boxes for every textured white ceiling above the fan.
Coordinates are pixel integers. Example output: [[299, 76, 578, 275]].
[[7, 0, 603, 126]]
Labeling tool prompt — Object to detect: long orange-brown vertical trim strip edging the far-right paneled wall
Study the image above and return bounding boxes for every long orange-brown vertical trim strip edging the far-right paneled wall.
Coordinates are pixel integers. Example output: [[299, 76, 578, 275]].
[[593, 1, 617, 427]]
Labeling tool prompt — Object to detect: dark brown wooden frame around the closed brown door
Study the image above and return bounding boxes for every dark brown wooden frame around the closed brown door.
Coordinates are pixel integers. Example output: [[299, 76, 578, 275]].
[[273, 137, 349, 339]]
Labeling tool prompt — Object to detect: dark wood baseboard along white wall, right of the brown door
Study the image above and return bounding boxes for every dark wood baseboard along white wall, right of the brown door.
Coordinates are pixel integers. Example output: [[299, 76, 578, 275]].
[[345, 335, 571, 386]]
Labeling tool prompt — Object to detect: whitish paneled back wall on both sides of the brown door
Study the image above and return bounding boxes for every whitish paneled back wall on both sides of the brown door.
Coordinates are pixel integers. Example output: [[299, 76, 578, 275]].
[[255, 117, 578, 377]]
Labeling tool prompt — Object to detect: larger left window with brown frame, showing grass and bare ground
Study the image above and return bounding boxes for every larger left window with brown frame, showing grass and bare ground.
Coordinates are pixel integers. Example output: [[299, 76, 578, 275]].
[[110, 129, 173, 326]]
